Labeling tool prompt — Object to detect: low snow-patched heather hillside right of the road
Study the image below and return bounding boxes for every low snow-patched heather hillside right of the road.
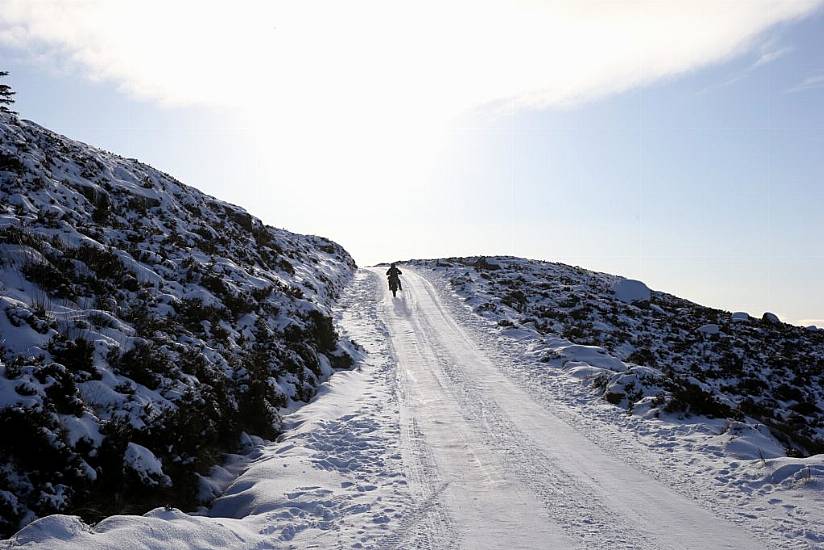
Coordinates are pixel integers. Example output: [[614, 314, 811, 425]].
[[412, 257, 824, 457]]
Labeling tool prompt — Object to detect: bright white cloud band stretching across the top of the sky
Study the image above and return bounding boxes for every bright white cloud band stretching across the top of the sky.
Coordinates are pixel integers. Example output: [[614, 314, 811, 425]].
[[0, 0, 820, 113]]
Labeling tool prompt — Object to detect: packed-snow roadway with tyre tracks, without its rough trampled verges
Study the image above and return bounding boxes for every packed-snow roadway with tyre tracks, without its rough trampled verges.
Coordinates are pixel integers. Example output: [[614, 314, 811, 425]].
[[380, 269, 763, 549]]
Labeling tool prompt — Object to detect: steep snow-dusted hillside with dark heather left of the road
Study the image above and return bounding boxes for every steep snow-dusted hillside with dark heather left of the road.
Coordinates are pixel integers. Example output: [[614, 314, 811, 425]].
[[0, 113, 355, 535]]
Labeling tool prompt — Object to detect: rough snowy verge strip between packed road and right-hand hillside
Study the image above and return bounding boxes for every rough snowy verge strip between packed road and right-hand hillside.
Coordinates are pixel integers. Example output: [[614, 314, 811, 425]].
[[424, 270, 792, 549]]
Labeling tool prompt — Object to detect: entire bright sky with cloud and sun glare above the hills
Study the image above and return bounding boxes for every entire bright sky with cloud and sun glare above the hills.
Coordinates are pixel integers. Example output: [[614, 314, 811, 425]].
[[0, 0, 824, 327]]
